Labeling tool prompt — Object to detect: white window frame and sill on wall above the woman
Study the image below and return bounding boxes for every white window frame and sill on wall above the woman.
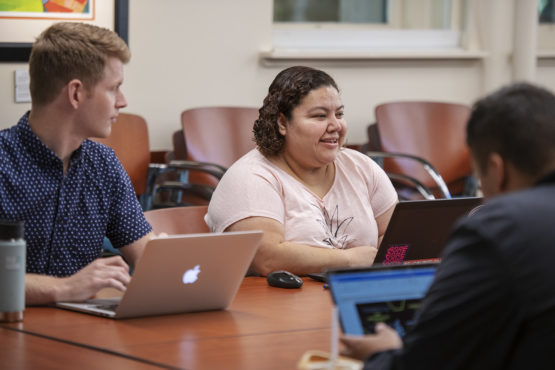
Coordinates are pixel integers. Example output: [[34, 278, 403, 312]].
[[263, 0, 484, 59]]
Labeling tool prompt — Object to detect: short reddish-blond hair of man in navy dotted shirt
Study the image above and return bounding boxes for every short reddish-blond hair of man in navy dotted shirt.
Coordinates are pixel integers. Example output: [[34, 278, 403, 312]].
[[29, 22, 131, 106]]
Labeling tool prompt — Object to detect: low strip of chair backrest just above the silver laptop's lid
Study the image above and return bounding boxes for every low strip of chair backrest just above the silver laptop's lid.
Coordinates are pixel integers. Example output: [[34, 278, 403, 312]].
[[145, 206, 210, 235]]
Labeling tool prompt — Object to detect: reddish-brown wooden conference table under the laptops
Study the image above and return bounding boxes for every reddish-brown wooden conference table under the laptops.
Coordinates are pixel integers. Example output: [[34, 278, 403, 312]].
[[0, 277, 332, 370]]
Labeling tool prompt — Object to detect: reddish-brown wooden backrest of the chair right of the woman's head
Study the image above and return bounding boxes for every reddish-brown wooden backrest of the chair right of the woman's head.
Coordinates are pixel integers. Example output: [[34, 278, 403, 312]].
[[376, 101, 472, 194]]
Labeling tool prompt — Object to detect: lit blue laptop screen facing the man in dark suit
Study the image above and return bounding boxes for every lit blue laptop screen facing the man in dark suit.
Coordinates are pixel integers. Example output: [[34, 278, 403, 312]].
[[327, 263, 437, 336]]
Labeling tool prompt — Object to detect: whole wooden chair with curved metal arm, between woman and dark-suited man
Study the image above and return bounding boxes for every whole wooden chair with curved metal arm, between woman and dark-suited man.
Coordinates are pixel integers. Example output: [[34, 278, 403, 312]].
[[367, 101, 476, 199]]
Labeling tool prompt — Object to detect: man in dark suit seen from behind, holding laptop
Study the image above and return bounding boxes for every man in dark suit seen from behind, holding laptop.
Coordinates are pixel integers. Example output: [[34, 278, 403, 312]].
[[341, 83, 555, 370]]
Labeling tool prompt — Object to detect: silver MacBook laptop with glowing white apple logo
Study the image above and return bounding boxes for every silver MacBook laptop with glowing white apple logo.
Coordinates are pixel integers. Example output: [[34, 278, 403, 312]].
[[56, 231, 262, 319]]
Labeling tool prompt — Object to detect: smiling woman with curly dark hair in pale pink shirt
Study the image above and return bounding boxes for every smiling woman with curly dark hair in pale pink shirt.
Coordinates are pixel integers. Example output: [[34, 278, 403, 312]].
[[206, 66, 397, 275]]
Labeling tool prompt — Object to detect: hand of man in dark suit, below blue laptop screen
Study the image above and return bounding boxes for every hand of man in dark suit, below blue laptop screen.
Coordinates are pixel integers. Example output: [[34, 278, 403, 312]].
[[339, 323, 403, 361]]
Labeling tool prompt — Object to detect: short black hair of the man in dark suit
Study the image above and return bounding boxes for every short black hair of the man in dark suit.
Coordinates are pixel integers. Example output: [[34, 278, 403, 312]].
[[467, 83, 555, 177]]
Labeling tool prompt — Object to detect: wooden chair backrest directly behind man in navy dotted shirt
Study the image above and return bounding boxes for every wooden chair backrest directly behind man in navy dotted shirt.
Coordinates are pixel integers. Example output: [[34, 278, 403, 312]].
[[93, 113, 150, 195]]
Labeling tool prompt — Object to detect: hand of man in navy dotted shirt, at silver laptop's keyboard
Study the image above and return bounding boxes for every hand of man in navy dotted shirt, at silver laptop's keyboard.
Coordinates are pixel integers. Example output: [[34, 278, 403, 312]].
[[56, 256, 131, 301]]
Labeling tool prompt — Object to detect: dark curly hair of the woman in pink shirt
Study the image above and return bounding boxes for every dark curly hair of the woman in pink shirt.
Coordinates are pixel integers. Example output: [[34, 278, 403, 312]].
[[253, 66, 339, 157]]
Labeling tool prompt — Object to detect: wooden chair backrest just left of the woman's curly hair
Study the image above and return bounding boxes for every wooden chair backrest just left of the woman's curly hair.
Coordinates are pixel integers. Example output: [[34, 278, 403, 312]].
[[181, 107, 258, 167]]
